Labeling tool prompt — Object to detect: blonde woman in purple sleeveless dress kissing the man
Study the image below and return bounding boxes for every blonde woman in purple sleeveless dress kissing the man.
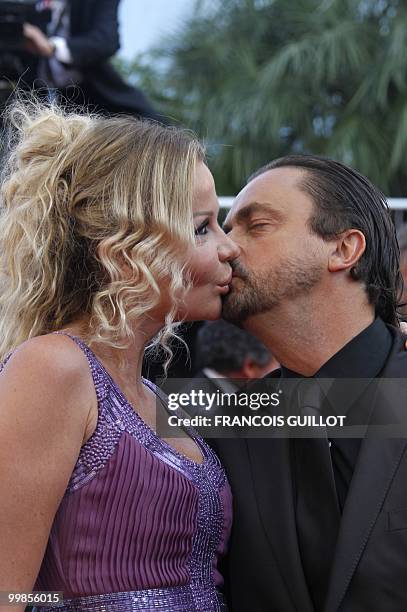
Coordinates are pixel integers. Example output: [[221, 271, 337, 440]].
[[0, 105, 238, 612]]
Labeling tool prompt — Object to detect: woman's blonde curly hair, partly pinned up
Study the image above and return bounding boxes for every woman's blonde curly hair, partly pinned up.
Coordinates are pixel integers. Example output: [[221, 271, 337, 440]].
[[0, 100, 204, 366]]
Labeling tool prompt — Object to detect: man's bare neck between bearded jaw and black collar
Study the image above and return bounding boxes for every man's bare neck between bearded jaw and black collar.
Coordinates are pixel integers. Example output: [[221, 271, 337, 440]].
[[244, 294, 375, 376]]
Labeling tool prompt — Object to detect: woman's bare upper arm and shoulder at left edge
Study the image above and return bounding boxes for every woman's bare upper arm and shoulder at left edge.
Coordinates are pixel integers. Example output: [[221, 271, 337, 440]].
[[0, 335, 96, 610]]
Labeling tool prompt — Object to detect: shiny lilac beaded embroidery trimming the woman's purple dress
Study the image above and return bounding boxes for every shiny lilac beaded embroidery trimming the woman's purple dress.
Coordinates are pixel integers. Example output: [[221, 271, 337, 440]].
[[0, 332, 231, 612]]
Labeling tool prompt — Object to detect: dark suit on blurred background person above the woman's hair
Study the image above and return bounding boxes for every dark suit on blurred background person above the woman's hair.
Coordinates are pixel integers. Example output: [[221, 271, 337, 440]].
[[37, 0, 164, 122]]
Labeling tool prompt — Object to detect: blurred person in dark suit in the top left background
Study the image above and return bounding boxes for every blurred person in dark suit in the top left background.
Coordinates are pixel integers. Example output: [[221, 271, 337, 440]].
[[19, 0, 164, 122]]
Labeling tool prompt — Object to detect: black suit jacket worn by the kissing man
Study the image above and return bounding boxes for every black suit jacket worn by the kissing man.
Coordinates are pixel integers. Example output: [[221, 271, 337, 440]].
[[210, 328, 407, 612]]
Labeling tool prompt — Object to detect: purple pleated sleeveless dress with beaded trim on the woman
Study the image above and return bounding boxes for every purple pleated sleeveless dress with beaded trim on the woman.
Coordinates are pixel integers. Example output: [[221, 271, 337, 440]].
[[3, 332, 232, 612]]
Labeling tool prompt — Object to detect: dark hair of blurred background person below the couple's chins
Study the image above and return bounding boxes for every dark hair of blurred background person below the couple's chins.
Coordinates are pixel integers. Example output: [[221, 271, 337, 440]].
[[196, 319, 271, 374]]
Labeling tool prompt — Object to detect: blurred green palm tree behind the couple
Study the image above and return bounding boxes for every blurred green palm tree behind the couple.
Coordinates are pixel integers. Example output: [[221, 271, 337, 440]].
[[117, 0, 407, 196]]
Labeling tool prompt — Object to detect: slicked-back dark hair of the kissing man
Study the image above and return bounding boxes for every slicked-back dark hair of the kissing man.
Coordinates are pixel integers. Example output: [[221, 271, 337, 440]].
[[248, 155, 403, 326]]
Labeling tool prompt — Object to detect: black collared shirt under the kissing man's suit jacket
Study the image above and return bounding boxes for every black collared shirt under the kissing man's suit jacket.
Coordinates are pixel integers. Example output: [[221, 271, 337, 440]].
[[281, 318, 392, 511]]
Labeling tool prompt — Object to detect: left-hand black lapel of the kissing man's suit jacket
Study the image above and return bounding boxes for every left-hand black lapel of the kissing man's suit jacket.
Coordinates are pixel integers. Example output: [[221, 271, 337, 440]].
[[247, 438, 313, 612]]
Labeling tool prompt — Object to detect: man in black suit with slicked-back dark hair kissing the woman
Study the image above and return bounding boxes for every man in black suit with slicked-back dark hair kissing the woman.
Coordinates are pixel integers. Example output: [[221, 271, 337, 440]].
[[217, 156, 407, 612]]
